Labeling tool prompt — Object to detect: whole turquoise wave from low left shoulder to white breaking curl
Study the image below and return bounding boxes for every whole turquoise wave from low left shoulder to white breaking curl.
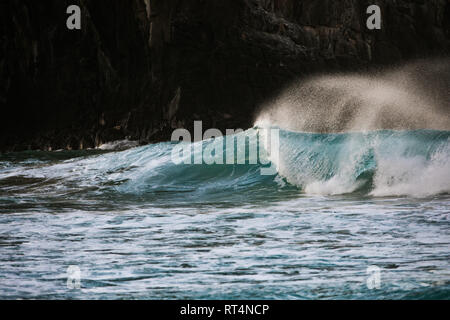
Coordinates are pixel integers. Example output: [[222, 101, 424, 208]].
[[0, 128, 450, 203]]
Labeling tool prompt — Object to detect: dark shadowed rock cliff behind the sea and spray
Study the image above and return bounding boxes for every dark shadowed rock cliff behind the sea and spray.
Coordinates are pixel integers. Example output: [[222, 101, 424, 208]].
[[0, 0, 450, 150]]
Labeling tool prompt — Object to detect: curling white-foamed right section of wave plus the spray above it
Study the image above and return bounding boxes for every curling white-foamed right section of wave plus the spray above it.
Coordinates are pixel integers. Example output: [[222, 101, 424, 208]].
[[251, 59, 450, 197]]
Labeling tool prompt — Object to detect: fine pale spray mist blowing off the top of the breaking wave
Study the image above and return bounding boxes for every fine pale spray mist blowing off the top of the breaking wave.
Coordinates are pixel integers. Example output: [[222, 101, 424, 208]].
[[255, 59, 450, 132]]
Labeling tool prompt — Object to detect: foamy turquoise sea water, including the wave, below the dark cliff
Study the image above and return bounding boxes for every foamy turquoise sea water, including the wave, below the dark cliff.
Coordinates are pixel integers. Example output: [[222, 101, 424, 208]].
[[0, 129, 450, 299]]
